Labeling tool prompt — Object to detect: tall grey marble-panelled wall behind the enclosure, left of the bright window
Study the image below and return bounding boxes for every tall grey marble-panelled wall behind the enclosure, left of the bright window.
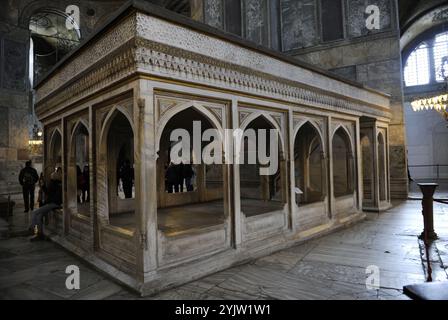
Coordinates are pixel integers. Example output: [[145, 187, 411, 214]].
[[282, 0, 407, 198]]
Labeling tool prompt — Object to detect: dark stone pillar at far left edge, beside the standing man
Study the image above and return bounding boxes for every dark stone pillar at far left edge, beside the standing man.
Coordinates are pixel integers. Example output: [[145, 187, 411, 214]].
[[0, 26, 30, 198]]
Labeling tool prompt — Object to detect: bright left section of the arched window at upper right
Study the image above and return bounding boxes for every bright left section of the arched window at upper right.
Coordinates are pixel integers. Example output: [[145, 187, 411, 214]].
[[404, 43, 431, 87]]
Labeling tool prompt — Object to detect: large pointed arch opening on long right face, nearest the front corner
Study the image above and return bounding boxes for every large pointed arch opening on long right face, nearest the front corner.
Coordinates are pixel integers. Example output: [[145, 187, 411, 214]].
[[157, 107, 227, 235]]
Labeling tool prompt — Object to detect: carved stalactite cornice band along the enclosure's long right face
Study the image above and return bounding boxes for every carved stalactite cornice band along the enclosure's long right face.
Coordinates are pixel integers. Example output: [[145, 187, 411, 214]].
[[136, 38, 390, 117]]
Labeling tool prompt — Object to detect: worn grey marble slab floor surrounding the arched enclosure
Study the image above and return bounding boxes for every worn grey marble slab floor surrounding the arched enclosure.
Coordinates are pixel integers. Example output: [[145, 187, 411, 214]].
[[0, 201, 448, 300]]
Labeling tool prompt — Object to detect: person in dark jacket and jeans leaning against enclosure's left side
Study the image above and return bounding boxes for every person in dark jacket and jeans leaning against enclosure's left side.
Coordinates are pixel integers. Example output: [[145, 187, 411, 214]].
[[30, 167, 62, 241]]
